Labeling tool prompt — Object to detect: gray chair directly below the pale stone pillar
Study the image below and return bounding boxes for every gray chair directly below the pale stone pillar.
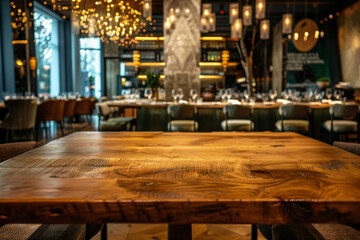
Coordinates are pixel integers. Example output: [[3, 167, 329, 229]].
[[167, 104, 199, 132]]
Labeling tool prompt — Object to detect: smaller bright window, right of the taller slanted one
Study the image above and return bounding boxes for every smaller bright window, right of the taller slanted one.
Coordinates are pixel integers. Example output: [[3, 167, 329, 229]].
[[80, 38, 101, 98]]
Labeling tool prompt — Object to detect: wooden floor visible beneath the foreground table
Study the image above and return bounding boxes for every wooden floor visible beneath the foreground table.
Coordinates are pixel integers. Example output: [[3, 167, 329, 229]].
[[92, 224, 265, 240]]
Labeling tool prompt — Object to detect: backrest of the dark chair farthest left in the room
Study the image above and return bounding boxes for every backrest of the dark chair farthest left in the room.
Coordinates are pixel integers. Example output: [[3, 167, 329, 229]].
[[4, 98, 37, 130]]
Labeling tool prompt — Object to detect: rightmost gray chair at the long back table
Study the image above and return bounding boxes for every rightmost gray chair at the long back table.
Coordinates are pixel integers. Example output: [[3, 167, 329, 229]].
[[323, 104, 360, 144]]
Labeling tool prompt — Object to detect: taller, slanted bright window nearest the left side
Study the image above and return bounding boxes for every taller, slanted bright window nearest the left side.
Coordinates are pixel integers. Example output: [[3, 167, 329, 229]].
[[34, 8, 60, 97]]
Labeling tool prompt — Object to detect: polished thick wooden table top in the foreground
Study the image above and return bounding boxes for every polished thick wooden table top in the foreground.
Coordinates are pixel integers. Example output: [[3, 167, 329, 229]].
[[0, 132, 360, 224]]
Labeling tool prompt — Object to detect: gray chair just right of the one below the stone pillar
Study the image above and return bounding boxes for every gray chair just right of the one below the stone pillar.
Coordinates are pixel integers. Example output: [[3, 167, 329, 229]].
[[221, 105, 254, 131]]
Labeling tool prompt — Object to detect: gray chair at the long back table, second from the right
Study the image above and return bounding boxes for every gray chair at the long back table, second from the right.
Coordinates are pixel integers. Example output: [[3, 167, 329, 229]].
[[275, 104, 310, 134]]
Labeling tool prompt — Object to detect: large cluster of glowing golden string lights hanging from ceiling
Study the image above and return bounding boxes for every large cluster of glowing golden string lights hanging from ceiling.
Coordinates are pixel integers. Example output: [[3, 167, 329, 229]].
[[72, 0, 152, 46]]
